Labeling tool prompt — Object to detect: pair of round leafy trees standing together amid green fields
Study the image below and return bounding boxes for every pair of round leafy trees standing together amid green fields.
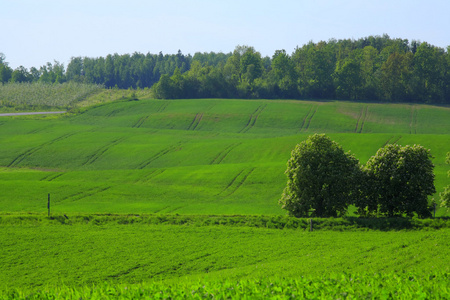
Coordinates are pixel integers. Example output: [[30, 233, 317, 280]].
[[279, 134, 436, 218]]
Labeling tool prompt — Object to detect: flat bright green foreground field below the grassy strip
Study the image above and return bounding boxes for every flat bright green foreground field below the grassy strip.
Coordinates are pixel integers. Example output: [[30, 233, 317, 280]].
[[0, 223, 450, 299]]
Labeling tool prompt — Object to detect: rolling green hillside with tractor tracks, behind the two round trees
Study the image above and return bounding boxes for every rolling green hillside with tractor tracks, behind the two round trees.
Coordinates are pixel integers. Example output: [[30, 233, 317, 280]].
[[0, 99, 450, 215]]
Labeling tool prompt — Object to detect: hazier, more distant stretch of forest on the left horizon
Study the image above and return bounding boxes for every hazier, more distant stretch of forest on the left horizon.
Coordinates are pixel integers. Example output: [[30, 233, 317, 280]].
[[0, 51, 225, 89]]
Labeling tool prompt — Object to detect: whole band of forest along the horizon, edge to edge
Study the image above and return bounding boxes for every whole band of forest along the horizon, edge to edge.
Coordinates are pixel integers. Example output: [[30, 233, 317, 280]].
[[0, 35, 450, 104]]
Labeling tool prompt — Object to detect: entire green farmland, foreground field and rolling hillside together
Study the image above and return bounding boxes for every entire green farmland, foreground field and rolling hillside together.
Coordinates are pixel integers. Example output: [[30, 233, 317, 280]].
[[0, 96, 450, 299]]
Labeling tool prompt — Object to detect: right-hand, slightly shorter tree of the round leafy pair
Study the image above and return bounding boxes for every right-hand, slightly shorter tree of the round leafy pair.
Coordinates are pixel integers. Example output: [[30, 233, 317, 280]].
[[362, 145, 436, 217]]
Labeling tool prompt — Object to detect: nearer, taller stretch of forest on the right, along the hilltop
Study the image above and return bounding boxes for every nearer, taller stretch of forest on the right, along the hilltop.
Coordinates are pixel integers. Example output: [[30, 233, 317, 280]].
[[154, 36, 450, 103]]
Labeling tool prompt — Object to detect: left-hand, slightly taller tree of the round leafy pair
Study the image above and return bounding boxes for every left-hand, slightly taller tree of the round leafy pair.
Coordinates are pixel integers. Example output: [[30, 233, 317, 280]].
[[279, 134, 360, 217]]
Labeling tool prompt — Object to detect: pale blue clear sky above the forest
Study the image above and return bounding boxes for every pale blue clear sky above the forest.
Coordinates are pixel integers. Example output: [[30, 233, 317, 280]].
[[0, 0, 450, 69]]
